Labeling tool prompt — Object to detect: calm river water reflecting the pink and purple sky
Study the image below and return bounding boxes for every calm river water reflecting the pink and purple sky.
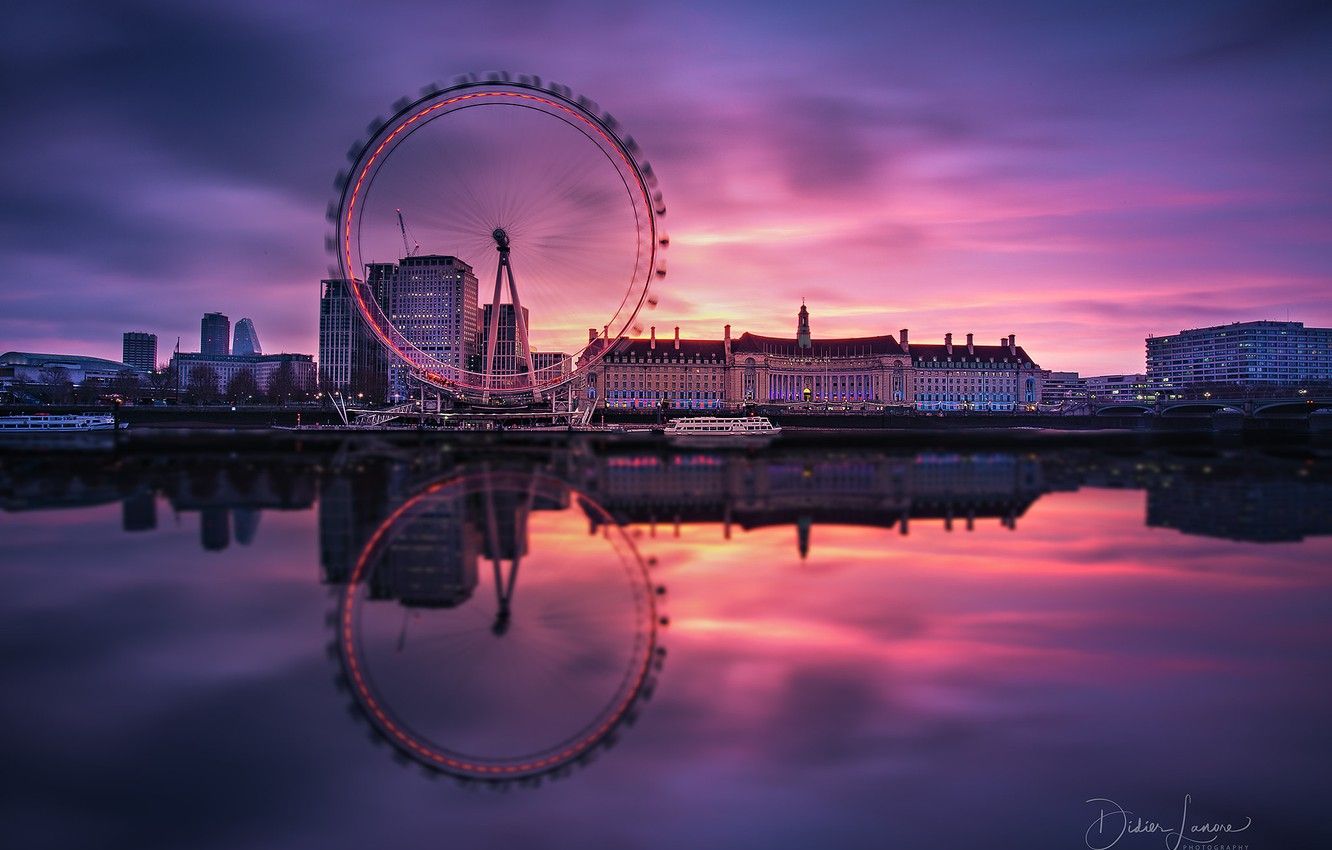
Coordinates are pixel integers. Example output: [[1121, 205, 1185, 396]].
[[0, 446, 1332, 850]]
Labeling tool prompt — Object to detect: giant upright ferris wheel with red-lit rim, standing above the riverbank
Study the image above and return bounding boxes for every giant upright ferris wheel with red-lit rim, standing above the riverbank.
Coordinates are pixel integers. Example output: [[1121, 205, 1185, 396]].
[[326, 73, 670, 398]]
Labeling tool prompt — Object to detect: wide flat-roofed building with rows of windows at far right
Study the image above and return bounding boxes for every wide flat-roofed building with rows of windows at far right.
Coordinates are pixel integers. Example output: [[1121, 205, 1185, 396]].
[[1147, 321, 1332, 390]]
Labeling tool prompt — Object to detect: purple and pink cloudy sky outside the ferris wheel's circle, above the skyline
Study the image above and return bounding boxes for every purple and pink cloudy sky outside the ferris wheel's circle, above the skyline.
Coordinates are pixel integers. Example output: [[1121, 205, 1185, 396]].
[[0, 0, 1332, 374]]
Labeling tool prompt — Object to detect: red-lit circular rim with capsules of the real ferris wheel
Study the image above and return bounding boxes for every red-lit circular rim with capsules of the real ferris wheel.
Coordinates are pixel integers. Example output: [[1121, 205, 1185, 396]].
[[326, 73, 669, 397]]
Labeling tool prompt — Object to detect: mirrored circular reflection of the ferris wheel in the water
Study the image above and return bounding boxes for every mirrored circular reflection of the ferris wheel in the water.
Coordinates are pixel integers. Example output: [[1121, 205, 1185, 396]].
[[332, 469, 665, 783]]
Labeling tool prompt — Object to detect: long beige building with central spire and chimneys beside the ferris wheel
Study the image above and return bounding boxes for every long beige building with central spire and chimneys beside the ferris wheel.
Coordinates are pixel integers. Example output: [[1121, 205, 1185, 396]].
[[587, 304, 1043, 410]]
